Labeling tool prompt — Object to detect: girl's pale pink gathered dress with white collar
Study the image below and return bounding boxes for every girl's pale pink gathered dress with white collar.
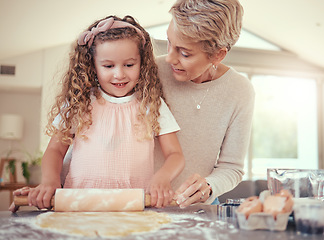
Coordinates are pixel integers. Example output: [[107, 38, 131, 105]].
[[64, 90, 179, 189]]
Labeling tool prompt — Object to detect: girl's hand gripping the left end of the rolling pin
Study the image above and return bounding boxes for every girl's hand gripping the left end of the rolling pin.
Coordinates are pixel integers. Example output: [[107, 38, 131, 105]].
[[28, 183, 61, 209]]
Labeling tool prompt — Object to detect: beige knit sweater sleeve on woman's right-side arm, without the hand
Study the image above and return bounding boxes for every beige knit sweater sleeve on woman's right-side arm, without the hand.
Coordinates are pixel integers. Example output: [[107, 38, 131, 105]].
[[206, 79, 255, 204]]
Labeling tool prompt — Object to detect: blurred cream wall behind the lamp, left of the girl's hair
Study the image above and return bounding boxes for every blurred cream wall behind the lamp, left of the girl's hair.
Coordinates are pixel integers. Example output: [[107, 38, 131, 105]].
[[0, 45, 69, 211]]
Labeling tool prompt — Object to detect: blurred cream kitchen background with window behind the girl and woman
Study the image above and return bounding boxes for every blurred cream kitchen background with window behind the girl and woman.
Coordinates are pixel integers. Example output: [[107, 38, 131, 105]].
[[0, 0, 324, 210]]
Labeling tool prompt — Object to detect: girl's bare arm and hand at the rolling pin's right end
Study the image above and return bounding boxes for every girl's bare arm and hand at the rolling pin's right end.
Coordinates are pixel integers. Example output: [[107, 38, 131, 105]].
[[150, 132, 185, 208]]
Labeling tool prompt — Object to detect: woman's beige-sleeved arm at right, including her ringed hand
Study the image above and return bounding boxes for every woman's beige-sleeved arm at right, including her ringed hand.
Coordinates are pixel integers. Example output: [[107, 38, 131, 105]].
[[176, 77, 255, 207]]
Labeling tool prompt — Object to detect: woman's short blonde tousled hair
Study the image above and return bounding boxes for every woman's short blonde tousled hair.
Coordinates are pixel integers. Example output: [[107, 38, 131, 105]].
[[170, 0, 243, 56]]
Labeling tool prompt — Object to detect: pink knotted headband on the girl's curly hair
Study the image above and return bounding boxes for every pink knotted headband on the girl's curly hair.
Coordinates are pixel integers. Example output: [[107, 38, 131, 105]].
[[78, 17, 145, 47]]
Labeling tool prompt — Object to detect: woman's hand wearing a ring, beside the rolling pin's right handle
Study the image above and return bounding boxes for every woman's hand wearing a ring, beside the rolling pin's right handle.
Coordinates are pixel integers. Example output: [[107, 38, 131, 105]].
[[174, 174, 211, 208]]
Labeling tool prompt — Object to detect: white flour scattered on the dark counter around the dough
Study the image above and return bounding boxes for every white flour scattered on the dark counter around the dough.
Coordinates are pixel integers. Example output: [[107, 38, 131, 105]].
[[0, 208, 238, 240]]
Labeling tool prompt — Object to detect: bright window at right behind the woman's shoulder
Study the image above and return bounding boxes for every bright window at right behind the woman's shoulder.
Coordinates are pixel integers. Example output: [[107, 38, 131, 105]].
[[245, 75, 318, 179]]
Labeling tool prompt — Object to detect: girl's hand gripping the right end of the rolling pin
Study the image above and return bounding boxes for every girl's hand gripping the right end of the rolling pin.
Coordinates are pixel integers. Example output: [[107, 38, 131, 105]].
[[148, 174, 174, 208]]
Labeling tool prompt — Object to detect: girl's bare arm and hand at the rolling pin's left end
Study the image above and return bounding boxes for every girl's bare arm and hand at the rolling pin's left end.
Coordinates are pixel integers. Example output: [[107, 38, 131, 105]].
[[28, 136, 69, 209]]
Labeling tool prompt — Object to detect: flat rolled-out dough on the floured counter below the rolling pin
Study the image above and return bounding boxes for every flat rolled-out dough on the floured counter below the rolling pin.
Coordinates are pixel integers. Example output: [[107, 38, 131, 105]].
[[36, 211, 171, 237]]
